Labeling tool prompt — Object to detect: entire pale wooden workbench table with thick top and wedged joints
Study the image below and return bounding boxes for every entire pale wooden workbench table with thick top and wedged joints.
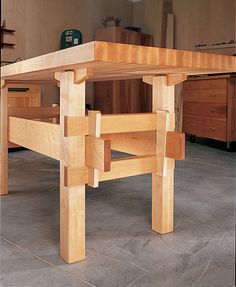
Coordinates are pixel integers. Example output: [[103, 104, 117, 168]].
[[0, 42, 236, 263]]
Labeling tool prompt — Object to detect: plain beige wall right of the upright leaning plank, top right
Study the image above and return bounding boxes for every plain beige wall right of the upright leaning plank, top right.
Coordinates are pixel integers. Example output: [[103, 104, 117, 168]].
[[172, 0, 236, 50]]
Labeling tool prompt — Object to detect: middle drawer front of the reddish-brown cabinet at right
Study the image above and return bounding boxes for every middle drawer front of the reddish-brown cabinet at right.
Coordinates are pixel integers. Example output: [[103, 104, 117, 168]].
[[183, 102, 227, 118]]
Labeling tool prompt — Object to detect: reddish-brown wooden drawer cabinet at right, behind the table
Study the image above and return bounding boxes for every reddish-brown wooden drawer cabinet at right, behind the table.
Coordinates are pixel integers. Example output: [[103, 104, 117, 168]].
[[183, 75, 236, 145]]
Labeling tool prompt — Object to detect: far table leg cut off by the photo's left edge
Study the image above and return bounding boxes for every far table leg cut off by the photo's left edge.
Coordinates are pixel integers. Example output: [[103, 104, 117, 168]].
[[0, 82, 8, 195]]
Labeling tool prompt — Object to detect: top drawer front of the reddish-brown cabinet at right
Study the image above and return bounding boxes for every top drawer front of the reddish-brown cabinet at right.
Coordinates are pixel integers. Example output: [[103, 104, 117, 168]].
[[183, 89, 227, 104]]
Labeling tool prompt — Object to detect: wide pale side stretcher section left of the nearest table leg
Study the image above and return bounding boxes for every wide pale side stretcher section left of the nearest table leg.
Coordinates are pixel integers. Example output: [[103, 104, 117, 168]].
[[9, 117, 60, 160]]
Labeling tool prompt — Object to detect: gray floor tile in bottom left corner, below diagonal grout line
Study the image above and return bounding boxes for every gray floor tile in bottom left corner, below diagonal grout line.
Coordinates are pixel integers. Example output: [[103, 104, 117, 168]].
[[0, 240, 95, 287]]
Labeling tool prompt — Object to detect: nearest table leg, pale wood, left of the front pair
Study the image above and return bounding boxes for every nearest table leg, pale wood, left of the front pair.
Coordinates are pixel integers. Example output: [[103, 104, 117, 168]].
[[57, 71, 85, 263]]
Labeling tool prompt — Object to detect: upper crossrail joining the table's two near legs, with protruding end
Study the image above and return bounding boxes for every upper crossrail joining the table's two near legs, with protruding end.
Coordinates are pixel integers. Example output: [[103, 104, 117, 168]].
[[65, 113, 157, 137]]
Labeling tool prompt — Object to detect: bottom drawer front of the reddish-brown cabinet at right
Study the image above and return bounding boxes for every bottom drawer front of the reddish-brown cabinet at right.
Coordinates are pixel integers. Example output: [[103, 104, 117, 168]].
[[183, 115, 226, 141]]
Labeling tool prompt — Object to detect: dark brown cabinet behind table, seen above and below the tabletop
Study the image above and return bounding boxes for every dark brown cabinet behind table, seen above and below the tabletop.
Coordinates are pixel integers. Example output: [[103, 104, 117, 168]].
[[94, 27, 152, 114]]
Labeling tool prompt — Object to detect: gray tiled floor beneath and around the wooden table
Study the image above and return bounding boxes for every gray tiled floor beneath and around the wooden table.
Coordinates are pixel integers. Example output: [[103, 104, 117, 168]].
[[0, 141, 236, 287]]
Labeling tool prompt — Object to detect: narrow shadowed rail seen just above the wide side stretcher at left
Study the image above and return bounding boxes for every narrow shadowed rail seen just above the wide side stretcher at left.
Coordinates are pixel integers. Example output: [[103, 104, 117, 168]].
[[8, 107, 60, 119]]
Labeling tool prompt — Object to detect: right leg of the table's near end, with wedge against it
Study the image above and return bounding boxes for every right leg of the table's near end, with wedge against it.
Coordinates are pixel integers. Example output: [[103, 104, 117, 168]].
[[152, 76, 175, 234]]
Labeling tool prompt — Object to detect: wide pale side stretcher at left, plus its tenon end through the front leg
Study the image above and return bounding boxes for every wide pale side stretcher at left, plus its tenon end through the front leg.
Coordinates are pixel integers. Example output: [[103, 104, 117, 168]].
[[9, 117, 111, 171]]
